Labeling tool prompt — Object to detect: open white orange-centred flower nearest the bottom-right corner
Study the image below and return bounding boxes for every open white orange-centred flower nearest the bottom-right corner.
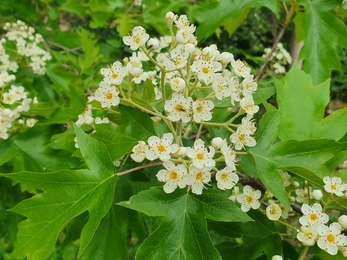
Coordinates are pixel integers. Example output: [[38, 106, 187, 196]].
[[317, 222, 347, 255]]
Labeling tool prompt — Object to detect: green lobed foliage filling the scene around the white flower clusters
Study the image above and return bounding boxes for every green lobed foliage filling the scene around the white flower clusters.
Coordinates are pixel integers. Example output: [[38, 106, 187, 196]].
[[0, 0, 347, 260]]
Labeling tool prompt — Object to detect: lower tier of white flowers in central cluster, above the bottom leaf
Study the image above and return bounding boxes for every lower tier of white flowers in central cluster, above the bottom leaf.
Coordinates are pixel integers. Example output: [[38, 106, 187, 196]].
[[130, 133, 239, 194]]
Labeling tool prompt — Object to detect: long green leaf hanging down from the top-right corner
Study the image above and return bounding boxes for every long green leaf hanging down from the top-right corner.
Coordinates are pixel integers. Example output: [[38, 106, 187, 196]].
[[300, 0, 347, 84]]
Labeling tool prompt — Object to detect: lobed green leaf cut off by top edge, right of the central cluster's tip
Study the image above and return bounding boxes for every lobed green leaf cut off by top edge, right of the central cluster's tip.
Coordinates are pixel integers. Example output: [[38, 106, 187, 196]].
[[193, 0, 278, 40]]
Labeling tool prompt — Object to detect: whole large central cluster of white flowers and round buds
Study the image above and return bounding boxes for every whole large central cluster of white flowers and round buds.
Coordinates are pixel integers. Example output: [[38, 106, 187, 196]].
[[77, 12, 259, 194]]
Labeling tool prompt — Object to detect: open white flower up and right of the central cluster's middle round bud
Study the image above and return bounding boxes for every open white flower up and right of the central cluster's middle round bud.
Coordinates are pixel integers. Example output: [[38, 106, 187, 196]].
[[190, 60, 222, 84]]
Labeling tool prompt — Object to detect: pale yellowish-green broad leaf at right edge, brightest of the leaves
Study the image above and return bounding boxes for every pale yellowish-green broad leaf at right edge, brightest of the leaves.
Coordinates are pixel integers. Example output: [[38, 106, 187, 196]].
[[276, 64, 347, 141]]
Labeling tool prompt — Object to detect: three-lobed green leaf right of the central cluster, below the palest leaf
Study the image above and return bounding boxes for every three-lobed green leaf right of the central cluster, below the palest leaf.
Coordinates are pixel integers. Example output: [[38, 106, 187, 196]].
[[248, 111, 342, 208]]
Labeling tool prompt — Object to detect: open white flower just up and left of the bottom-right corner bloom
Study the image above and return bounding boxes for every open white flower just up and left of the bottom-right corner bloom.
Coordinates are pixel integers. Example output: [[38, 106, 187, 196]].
[[299, 203, 329, 227]]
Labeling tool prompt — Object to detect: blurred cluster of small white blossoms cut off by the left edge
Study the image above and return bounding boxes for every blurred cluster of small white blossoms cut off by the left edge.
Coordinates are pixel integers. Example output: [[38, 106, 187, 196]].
[[0, 21, 51, 139]]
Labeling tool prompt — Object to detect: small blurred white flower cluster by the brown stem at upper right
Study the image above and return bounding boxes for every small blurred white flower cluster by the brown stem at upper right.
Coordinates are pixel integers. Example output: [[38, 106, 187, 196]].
[[263, 43, 293, 74]]
